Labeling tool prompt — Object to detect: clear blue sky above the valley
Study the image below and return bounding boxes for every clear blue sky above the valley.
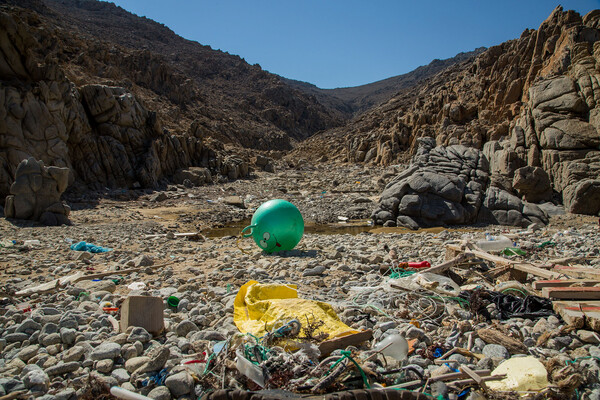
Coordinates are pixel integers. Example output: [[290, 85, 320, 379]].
[[106, 0, 600, 88]]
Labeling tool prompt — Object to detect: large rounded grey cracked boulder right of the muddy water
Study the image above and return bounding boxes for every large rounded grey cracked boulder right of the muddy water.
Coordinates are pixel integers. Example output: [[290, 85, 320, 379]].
[[372, 138, 488, 229]]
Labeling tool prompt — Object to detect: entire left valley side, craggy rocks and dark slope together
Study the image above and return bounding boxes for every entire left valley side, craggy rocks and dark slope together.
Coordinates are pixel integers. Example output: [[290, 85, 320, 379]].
[[0, 0, 352, 198]]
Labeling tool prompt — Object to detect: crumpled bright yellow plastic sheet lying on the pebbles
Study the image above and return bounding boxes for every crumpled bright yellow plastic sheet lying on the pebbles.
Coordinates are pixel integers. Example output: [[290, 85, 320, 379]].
[[233, 281, 358, 339]]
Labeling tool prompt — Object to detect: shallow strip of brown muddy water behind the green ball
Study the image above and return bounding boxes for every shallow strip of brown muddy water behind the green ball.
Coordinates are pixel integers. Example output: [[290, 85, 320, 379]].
[[202, 220, 483, 238]]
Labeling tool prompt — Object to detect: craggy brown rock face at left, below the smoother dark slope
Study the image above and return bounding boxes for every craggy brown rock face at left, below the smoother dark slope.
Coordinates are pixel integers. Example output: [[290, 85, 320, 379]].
[[0, 11, 248, 197]]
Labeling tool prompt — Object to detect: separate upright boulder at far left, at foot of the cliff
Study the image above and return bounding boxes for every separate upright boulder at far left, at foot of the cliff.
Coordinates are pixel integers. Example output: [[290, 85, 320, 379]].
[[4, 157, 71, 225]]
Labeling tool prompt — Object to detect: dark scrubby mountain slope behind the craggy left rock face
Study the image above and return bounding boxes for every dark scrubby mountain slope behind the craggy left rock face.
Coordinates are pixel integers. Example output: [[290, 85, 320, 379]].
[[14, 0, 343, 150]]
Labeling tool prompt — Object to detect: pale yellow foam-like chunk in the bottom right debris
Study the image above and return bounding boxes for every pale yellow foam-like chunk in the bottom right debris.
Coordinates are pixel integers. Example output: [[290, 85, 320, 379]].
[[486, 356, 549, 391]]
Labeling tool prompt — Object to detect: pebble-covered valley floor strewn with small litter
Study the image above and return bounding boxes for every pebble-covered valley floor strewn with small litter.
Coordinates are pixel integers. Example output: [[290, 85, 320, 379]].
[[0, 165, 600, 399]]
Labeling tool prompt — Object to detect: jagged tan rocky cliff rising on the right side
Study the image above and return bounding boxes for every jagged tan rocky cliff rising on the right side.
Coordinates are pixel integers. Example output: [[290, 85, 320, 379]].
[[300, 7, 600, 214]]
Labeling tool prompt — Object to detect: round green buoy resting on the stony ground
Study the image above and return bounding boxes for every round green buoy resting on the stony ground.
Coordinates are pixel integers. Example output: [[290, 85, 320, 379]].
[[242, 199, 304, 253]]
